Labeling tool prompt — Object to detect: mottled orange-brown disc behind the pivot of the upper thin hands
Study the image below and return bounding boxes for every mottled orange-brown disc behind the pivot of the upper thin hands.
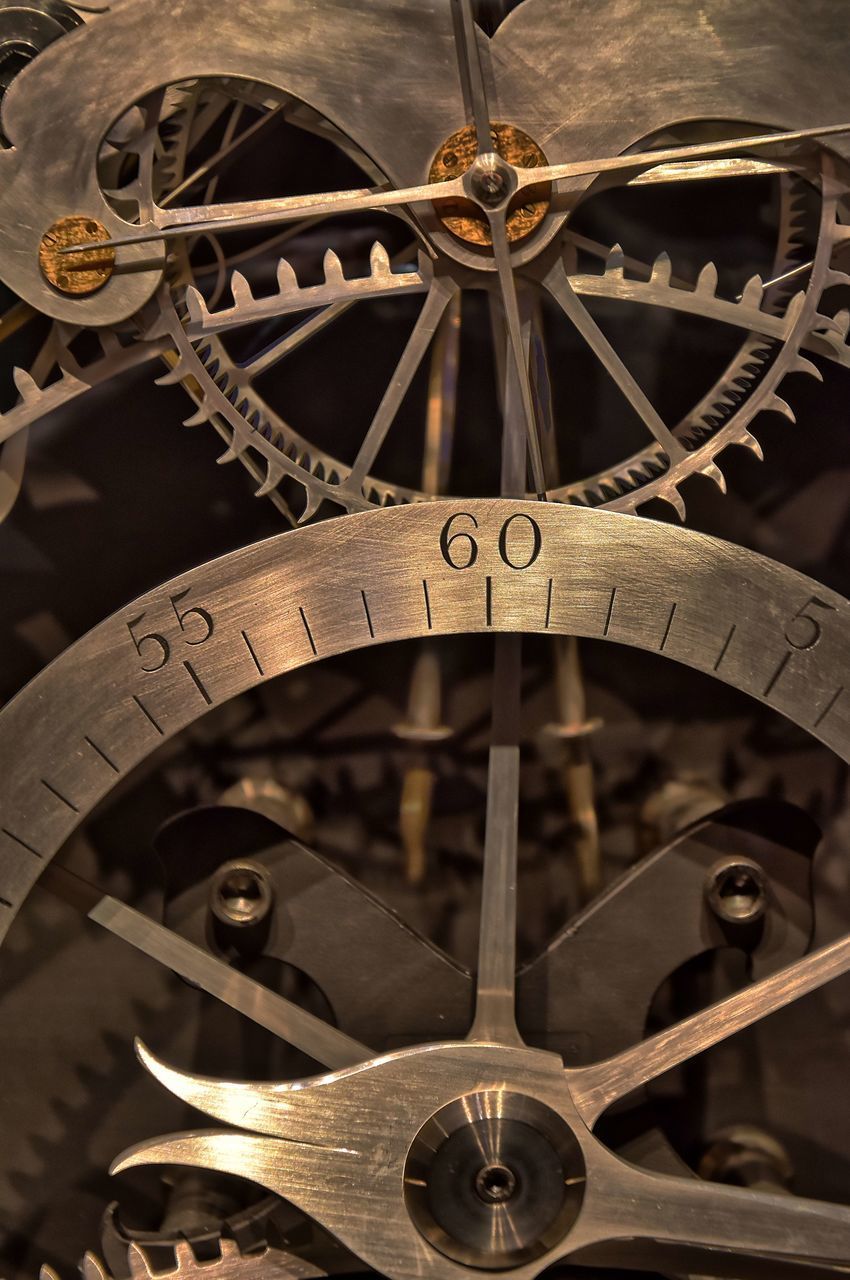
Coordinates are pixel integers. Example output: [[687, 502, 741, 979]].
[[428, 122, 550, 244]]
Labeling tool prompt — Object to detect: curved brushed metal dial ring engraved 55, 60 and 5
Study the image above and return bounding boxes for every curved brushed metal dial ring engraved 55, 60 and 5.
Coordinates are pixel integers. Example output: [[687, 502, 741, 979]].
[[0, 499, 850, 933]]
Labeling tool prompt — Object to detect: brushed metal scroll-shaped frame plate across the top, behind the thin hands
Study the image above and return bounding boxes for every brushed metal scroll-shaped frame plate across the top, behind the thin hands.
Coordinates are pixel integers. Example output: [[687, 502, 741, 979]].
[[0, 0, 850, 325]]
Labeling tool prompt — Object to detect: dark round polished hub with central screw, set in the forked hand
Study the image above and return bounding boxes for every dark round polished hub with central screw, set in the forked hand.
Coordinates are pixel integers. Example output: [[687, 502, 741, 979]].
[[405, 1089, 585, 1270]]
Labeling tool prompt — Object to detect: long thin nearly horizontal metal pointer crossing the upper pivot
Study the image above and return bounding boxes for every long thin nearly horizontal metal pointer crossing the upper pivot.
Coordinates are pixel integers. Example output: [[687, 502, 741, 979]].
[[60, 124, 850, 253]]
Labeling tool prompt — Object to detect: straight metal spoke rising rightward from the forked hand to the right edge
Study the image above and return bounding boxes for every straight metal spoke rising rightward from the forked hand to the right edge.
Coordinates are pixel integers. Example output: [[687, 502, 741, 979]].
[[567, 934, 850, 1125]]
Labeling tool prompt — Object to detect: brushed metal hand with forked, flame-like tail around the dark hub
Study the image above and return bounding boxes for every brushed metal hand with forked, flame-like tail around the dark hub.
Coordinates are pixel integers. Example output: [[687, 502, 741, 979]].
[[114, 1043, 850, 1280]]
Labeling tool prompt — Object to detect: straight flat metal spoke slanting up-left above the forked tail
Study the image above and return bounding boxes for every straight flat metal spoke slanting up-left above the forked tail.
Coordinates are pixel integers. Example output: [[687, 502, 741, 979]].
[[38, 867, 375, 1070]]
